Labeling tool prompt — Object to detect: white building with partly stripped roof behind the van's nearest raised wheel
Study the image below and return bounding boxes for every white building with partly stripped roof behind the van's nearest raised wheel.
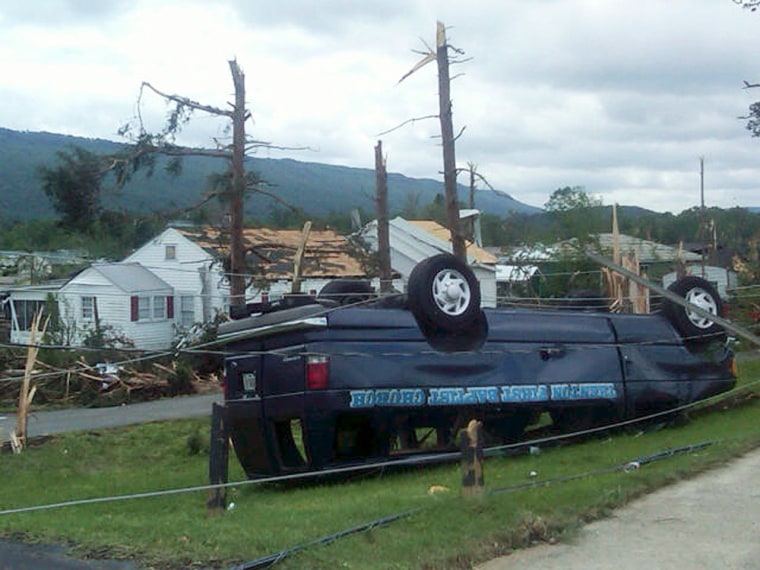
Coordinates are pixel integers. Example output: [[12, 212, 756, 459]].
[[361, 216, 496, 307]]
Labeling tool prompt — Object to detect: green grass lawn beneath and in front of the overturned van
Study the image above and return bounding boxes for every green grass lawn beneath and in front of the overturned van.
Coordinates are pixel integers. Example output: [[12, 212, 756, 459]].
[[0, 361, 760, 569]]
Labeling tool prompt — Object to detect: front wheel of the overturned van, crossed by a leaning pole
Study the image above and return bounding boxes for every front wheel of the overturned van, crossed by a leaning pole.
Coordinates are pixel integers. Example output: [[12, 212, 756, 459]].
[[662, 275, 726, 344]]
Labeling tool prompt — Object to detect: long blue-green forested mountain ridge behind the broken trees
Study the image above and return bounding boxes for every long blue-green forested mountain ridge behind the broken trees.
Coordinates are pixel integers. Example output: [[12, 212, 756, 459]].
[[0, 127, 543, 221]]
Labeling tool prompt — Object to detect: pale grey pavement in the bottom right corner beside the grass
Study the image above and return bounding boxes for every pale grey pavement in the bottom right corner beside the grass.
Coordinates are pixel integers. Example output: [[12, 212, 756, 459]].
[[476, 449, 760, 570]]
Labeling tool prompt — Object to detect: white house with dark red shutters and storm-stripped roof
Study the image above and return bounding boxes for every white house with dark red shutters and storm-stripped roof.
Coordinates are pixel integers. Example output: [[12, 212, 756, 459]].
[[5, 227, 372, 349]]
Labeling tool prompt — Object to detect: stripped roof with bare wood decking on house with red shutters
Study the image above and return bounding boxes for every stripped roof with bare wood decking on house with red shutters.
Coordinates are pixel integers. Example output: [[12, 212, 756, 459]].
[[175, 226, 366, 281]]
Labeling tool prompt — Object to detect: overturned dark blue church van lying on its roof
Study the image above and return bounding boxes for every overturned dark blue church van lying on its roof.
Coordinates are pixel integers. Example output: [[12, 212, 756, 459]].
[[218, 254, 736, 478]]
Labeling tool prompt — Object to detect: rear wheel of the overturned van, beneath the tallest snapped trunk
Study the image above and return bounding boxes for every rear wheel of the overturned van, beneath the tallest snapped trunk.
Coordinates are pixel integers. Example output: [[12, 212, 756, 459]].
[[407, 253, 481, 332]]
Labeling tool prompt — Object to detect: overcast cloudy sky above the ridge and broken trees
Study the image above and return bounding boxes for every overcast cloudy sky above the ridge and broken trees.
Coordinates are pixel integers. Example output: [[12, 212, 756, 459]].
[[0, 0, 760, 213]]
